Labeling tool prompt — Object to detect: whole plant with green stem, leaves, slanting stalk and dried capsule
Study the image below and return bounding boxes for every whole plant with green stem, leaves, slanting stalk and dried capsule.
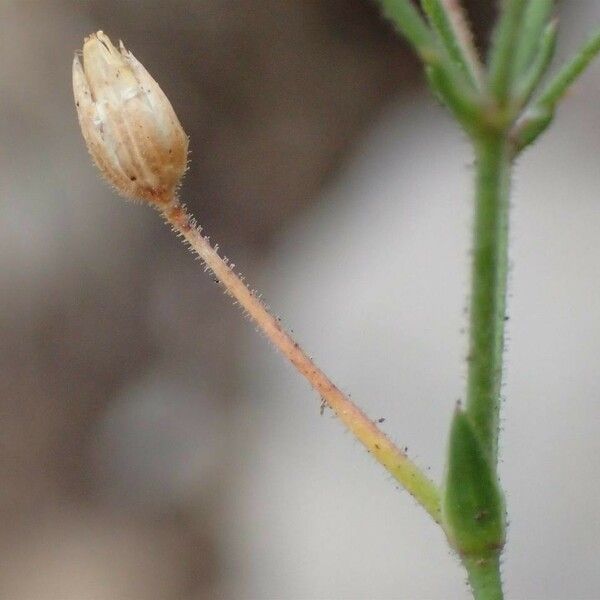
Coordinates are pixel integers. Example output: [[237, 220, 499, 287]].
[[73, 0, 600, 600]]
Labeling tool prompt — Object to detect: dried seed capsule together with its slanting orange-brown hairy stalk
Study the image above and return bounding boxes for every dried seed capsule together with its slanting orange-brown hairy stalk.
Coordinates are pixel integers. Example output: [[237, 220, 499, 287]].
[[73, 31, 441, 523]]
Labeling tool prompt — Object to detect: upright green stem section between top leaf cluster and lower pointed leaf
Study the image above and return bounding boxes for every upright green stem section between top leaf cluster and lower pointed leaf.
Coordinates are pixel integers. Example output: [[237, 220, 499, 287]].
[[466, 132, 510, 468]]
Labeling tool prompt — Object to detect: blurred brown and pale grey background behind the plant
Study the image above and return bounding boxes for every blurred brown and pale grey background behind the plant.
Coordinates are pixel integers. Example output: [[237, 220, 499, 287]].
[[0, 0, 600, 600]]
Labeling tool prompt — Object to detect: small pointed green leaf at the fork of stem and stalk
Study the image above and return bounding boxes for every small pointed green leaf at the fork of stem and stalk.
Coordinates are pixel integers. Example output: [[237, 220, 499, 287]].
[[442, 409, 505, 558]]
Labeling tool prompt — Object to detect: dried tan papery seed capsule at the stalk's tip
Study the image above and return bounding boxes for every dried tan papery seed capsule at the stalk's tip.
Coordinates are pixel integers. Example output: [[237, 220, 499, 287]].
[[73, 31, 188, 205]]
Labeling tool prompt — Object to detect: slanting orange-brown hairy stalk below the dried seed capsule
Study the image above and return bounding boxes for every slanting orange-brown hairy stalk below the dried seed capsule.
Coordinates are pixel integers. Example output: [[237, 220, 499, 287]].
[[159, 199, 441, 523]]
